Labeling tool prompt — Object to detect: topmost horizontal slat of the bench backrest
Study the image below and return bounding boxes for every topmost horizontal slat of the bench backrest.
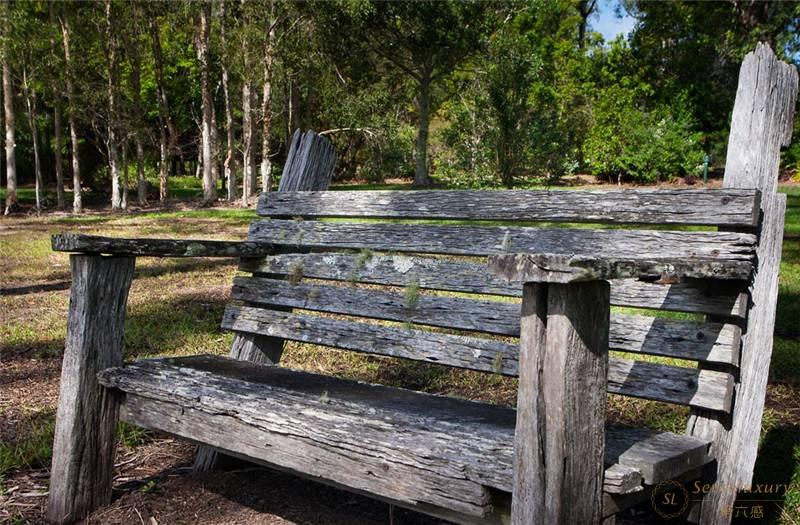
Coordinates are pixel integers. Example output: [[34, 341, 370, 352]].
[[258, 189, 759, 226]]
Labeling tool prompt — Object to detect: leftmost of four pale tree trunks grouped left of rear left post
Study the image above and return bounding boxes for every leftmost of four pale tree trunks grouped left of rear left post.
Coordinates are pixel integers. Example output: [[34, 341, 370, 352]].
[[196, 3, 217, 203]]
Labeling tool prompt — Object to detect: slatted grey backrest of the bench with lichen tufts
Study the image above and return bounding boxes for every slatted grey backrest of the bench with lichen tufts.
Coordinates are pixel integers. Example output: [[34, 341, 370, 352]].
[[223, 190, 759, 418]]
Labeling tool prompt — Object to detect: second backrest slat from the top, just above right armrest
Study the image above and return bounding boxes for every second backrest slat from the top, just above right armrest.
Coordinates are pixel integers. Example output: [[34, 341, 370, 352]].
[[249, 220, 756, 279]]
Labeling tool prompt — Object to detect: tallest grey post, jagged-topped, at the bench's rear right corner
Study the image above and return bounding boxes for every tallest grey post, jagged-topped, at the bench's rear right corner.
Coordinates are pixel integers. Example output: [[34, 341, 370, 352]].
[[688, 44, 798, 525]]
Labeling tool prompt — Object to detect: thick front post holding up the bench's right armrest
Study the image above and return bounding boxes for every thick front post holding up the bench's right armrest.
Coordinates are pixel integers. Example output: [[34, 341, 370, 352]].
[[511, 281, 610, 525]]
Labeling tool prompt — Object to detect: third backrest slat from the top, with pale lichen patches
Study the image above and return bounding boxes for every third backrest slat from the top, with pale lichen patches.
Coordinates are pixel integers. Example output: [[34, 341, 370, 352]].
[[239, 253, 746, 317]]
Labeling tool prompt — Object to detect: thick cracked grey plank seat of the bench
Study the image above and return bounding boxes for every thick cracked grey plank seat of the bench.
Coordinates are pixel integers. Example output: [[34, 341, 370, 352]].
[[99, 356, 710, 515]]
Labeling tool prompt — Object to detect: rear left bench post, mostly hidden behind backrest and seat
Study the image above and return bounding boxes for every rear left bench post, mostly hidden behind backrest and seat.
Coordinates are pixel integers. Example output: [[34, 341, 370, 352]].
[[194, 129, 336, 472]]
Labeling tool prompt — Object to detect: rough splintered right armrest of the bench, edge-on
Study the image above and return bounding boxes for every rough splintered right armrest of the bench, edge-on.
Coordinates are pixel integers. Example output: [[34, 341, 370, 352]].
[[488, 253, 752, 284]]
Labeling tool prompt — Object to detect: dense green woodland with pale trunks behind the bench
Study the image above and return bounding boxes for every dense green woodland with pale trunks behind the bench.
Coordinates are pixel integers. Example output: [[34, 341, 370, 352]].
[[0, 0, 800, 213]]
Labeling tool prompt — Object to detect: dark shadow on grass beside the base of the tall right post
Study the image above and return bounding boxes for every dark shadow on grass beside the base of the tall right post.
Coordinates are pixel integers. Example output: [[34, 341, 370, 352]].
[[733, 425, 800, 524]]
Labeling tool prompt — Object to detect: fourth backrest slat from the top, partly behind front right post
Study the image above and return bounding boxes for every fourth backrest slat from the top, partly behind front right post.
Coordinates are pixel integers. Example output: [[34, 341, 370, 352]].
[[232, 277, 739, 364]]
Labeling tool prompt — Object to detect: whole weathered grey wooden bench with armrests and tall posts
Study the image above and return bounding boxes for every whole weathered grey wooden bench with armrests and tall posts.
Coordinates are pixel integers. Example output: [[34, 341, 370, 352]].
[[49, 46, 797, 524]]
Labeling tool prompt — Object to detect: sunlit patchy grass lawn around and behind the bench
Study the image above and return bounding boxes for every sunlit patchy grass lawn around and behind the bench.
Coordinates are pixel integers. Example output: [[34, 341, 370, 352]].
[[0, 182, 800, 524]]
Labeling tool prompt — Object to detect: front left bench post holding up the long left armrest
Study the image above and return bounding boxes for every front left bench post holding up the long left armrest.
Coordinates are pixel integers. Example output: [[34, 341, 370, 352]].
[[47, 255, 134, 523]]
